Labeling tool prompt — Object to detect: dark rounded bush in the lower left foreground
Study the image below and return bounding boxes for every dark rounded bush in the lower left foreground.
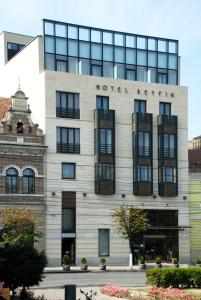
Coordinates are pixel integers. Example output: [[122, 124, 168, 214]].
[[0, 243, 47, 292]]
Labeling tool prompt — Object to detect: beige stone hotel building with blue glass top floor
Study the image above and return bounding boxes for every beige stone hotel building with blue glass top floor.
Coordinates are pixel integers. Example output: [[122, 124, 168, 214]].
[[0, 20, 190, 266]]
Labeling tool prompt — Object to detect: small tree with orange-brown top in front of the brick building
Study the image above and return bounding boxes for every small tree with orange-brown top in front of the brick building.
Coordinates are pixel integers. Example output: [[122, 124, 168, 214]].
[[2, 208, 40, 244]]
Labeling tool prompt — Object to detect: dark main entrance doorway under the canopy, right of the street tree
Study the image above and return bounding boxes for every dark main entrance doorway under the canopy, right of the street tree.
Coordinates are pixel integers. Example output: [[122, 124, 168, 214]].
[[144, 236, 167, 260]]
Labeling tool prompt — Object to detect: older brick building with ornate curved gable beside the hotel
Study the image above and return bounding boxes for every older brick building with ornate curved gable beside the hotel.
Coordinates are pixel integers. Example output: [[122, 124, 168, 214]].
[[0, 90, 46, 249]]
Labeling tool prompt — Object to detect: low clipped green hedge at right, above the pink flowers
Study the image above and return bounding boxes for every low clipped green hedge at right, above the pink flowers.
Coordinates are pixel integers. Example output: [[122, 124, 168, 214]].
[[146, 267, 201, 288]]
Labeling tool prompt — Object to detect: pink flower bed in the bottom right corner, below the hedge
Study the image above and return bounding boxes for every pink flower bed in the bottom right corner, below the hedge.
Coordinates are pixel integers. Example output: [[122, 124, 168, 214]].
[[147, 288, 195, 300]]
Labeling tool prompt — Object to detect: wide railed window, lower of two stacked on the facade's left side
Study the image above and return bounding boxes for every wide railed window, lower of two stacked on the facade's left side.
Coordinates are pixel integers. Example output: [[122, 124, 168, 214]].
[[57, 127, 80, 154]]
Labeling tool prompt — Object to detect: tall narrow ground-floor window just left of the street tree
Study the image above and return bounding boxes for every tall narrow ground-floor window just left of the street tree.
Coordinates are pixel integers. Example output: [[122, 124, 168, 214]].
[[98, 229, 110, 256]]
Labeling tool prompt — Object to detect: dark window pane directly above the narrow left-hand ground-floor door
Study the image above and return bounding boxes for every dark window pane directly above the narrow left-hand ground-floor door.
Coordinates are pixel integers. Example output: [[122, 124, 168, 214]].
[[62, 208, 75, 233]]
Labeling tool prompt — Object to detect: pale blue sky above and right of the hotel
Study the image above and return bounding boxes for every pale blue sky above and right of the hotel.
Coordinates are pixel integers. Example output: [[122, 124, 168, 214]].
[[0, 0, 201, 139]]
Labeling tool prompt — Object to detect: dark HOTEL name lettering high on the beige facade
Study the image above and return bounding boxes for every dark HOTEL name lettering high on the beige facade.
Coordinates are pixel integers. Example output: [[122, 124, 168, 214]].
[[96, 84, 174, 98]]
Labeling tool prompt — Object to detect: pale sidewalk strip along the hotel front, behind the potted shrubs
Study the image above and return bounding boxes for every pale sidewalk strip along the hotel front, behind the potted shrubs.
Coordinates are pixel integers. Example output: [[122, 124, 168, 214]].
[[44, 263, 188, 273]]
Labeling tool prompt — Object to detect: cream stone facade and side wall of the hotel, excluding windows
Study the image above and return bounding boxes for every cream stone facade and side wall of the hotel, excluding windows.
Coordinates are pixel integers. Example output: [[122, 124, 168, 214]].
[[0, 29, 190, 265]]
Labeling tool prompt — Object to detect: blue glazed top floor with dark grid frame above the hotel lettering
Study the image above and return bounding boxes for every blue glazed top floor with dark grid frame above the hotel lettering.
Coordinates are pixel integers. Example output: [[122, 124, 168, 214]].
[[43, 19, 179, 85]]
